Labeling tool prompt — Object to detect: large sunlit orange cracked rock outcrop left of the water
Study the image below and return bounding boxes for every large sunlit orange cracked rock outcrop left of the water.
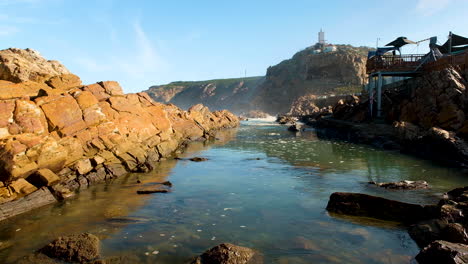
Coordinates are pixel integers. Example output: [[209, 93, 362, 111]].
[[0, 49, 239, 220]]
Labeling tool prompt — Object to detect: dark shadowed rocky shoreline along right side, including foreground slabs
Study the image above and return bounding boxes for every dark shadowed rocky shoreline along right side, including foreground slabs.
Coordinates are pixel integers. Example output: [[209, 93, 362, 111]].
[[270, 68, 468, 264]]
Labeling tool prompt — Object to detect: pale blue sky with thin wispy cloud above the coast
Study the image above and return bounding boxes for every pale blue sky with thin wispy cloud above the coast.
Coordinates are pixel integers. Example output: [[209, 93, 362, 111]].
[[0, 0, 468, 92]]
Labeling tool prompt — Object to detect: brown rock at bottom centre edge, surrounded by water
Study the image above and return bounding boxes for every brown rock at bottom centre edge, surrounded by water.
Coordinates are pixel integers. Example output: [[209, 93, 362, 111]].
[[191, 243, 263, 264]]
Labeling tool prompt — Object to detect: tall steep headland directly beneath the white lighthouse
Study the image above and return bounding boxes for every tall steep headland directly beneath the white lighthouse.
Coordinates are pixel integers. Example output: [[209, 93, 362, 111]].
[[252, 45, 369, 114]]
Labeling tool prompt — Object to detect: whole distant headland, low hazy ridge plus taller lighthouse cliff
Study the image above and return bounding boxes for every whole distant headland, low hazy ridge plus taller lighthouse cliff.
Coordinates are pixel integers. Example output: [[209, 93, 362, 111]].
[[146, 45, 369, 114]]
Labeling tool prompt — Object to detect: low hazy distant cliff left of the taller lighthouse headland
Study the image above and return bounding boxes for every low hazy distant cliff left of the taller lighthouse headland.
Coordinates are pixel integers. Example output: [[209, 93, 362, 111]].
[[146, 77, 264, 112]]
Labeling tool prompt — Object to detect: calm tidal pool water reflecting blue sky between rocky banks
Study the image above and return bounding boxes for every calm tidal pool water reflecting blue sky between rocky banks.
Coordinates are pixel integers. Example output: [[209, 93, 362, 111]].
[[0, 120, 468, 264]]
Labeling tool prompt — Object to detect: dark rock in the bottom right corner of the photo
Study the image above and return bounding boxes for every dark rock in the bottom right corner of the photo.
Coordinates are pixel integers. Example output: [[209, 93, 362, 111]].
[[416, 240, 468, 264]]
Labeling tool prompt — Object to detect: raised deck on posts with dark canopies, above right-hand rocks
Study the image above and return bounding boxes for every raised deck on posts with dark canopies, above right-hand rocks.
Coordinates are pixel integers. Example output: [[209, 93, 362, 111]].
[[366, 32, 468, 117]]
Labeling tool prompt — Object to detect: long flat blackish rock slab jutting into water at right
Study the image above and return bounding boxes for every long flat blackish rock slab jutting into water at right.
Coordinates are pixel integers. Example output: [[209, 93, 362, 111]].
[[327, 192, 437, 224]]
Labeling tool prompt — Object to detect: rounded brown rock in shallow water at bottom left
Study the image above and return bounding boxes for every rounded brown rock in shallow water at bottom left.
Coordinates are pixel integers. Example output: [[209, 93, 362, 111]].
[[39, 233, 100, 263]]
